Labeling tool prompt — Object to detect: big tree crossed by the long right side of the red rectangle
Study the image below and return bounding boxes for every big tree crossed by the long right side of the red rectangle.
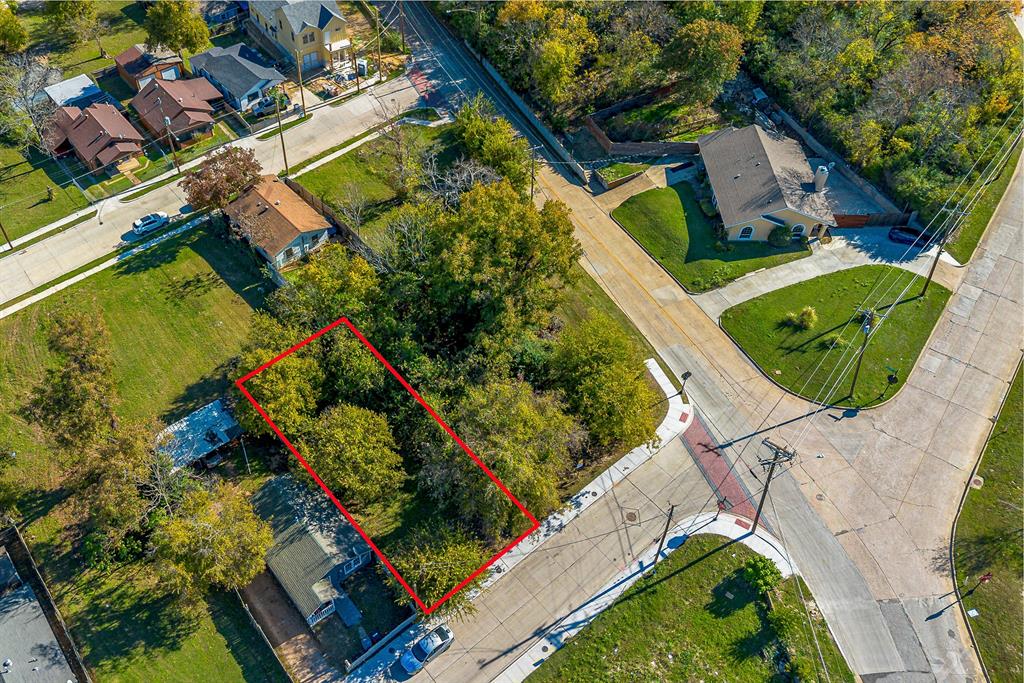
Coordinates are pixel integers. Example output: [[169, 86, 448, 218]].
[[419, 380, 581, 540]]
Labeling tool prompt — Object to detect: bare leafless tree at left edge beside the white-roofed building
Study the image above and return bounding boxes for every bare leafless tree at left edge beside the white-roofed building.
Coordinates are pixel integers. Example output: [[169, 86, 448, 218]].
[[0, 52, 61, 150]]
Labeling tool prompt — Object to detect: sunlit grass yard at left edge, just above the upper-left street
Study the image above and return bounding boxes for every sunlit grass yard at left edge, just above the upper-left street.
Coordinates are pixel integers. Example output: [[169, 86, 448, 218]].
[[0, 144, 89, 240]]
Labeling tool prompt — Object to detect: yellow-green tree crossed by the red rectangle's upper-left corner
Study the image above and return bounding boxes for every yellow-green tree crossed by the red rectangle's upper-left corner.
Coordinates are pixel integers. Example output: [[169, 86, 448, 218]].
[[237, 313, 324, 439]]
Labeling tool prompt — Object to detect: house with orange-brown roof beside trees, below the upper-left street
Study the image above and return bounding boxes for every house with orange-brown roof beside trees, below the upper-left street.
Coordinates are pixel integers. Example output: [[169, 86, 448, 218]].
[[224, 175, 332, 268]]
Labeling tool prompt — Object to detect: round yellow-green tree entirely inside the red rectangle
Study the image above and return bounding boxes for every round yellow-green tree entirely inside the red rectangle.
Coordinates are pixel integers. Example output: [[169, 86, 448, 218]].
[[296, 403, 406, 509]]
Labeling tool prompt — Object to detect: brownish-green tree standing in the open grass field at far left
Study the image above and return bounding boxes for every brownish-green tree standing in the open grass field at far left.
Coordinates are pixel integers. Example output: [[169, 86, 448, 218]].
[[30, 307, 116, 452]]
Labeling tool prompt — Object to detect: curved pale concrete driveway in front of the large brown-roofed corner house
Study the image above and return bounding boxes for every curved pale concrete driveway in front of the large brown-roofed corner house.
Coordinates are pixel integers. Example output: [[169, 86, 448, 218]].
[[691, 227, 962, 321]]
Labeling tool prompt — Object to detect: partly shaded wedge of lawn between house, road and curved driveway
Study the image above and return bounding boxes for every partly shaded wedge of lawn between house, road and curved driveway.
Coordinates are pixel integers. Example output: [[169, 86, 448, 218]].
[[611, 182, 811, 292]]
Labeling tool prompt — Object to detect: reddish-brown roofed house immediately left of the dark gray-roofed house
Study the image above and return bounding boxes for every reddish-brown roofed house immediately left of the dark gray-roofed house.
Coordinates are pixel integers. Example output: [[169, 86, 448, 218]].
[[131, 78, 222, 142]]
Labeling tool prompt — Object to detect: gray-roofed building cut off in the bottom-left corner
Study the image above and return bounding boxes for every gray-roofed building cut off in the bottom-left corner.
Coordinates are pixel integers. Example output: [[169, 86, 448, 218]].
[[0, 528, 83, 683]]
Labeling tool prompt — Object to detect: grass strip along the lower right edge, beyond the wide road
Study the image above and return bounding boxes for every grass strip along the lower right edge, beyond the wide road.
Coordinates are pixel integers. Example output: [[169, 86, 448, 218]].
[[954, 368, 1024, 683]]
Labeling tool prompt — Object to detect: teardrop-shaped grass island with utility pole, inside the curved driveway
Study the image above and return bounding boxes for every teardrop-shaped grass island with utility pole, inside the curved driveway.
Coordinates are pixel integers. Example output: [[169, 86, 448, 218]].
[[721, 265, 950, 408]]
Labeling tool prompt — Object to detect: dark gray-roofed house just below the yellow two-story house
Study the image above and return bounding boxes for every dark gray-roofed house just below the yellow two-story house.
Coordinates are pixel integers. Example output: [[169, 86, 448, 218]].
[[190, 43, 285, 112]]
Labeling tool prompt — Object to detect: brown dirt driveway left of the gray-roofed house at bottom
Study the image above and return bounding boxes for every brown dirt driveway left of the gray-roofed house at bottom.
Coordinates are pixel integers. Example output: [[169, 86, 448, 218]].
[[242, 571, 344, 683]]
